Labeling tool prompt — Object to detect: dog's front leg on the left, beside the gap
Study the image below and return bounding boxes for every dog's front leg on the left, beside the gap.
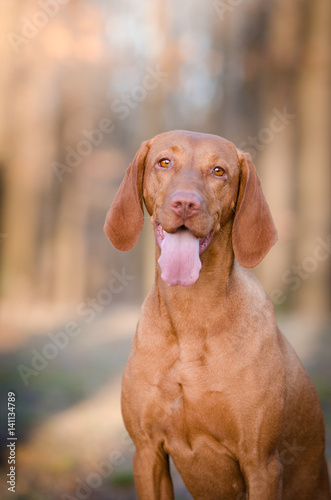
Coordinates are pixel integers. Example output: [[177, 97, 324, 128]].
[[133, 447, 174, 500]]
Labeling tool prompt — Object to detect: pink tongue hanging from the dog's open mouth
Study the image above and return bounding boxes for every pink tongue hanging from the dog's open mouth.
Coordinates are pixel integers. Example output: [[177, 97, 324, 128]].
[[158, 230, 201, 286]]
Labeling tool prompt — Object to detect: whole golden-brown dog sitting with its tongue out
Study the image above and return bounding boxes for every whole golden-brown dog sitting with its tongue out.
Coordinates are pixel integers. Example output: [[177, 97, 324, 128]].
[[105, 131, 331, 500]]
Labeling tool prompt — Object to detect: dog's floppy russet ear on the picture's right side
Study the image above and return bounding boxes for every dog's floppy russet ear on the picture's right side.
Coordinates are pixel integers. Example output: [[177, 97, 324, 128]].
[[232, 151, 277, 268]]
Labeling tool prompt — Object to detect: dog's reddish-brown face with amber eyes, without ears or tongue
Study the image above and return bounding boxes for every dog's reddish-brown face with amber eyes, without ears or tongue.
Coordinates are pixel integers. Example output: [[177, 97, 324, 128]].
[[143, 131, 240, 238]]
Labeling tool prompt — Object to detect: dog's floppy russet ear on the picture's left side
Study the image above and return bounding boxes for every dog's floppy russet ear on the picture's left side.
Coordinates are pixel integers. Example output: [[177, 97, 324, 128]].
[[103, 142, 148, 250]]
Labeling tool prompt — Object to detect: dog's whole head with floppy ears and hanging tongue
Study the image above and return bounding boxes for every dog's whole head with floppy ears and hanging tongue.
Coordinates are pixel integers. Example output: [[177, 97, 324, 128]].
[[104, 130, 277, 285]]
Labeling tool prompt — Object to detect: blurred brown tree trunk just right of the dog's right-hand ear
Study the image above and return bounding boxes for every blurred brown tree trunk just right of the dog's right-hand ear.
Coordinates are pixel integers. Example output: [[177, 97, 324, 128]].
[[256, 0, 309, 304]]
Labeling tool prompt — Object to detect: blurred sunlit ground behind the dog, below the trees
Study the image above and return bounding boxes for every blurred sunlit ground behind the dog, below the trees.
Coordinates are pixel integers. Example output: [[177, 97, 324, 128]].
[[0, 306, 331, 500]]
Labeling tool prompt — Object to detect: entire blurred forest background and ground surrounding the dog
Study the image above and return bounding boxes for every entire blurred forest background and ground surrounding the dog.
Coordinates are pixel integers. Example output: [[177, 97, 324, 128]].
[[0, 0, 331, 500]]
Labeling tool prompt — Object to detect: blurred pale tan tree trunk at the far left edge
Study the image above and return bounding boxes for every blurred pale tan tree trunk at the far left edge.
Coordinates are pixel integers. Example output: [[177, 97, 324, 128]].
[[1, 1, 55, 303]]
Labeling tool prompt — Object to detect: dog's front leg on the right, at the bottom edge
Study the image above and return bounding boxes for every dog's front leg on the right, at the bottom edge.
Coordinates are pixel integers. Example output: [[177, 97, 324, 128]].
[[243, 454, 283, 500]]
